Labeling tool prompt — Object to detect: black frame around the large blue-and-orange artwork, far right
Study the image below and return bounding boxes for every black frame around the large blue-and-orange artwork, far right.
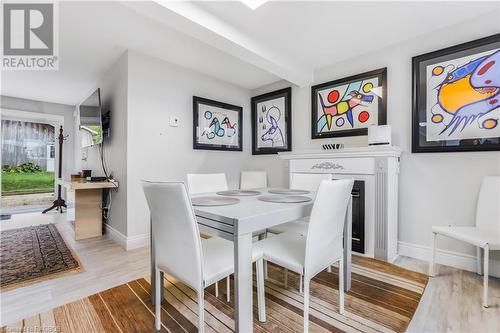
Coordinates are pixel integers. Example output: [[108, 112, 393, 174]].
[[411, 34, 500, 153]]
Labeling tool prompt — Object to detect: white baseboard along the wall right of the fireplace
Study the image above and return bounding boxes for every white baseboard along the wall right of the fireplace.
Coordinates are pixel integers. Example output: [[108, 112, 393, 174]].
[[398, 242, 500, 278]]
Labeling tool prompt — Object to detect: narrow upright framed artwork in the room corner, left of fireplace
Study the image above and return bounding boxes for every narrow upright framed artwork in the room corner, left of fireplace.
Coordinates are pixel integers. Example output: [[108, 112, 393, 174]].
[[252, 88, 292, 155]]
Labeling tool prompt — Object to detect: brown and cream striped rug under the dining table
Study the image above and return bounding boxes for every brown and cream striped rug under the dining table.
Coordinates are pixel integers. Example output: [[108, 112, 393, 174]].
[[2, 256, 427, 333]]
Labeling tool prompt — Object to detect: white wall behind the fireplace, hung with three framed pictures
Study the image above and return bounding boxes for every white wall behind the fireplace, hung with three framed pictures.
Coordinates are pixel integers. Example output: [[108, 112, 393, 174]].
[[252, 11, 500, 266]]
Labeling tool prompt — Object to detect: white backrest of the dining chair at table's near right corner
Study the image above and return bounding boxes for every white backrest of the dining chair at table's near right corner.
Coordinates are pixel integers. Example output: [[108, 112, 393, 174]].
[[304, 179, 354, 276]]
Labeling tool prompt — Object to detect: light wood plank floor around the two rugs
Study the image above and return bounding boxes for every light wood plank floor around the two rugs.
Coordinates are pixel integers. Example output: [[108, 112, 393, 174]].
[[0, 214, 500, 332]]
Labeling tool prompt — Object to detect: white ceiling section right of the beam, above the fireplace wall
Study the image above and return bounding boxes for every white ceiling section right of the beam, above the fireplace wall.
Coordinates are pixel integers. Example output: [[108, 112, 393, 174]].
[[196, 1, 500, 70]]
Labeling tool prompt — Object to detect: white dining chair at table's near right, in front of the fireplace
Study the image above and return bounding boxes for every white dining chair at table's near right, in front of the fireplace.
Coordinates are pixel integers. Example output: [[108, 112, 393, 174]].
[[254, 179, 354, 332]]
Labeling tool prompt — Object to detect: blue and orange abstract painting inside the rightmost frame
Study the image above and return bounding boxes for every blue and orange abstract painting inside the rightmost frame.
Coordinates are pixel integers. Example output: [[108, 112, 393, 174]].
[[427, 48, 500, 141]]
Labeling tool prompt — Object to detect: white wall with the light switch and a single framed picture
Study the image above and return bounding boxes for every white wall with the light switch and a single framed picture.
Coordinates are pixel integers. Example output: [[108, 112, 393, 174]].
[[127, 52, 258, 237]]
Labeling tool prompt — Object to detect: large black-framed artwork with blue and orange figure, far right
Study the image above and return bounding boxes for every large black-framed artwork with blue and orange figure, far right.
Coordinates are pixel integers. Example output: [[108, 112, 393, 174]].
[[412, 34, 500, 153]]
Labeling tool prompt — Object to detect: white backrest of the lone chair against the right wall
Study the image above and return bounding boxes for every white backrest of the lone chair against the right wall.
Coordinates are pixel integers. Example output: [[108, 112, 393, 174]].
[[476, 176, 500, 232]]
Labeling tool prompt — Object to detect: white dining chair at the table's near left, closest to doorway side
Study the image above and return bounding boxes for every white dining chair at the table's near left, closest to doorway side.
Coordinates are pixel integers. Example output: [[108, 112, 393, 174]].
[[142, 181, 266, 332]]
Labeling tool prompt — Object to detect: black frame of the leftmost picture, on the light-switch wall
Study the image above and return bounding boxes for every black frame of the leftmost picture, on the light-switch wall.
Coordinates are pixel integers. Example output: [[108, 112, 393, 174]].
[[193, 96, 243, 151]]
